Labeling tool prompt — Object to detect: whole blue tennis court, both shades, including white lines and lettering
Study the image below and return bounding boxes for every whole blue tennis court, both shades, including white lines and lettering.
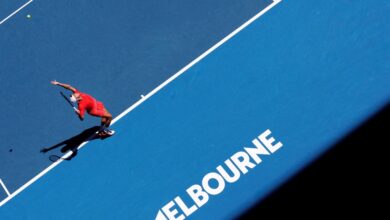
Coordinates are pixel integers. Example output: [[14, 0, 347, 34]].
[[0, 0, 390, 219]]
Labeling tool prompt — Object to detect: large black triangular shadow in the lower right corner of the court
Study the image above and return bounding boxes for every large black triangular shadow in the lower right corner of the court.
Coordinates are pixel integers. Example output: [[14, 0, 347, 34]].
[[238, 104, 390, 219]]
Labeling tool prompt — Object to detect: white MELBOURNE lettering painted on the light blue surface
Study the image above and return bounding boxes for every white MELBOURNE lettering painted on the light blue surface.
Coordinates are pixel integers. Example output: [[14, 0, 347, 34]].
[[156, 129, 283, 220]]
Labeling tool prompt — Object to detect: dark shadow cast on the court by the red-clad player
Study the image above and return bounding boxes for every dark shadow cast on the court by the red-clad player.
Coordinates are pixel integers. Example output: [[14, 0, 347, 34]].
[[41, 126, 101, 162]]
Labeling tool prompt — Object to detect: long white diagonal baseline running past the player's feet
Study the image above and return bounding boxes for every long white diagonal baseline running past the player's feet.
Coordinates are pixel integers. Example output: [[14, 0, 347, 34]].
[[0, 0, 281, 206]]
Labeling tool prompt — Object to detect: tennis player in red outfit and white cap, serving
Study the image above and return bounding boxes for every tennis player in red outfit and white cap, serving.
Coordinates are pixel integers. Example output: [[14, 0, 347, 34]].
[[51, 80, 115, 137]]
